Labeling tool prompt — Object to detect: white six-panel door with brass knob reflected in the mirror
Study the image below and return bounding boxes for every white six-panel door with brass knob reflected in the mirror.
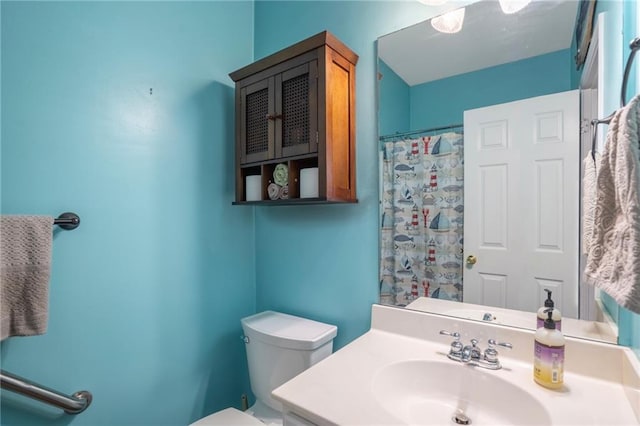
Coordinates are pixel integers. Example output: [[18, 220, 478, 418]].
[[463, 90, 580, 325]]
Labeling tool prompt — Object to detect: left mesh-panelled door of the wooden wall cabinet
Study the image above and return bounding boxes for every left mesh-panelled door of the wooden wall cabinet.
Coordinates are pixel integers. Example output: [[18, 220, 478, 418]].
[[238, 77, 275, 164]]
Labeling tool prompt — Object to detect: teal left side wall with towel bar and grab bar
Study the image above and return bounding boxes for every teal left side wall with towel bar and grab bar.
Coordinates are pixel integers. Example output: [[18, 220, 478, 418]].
[[1, 1, 255, 426]]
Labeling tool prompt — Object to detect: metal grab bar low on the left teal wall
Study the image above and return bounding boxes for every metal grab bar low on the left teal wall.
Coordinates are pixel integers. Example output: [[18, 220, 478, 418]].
[[0, 370, 93, 414]]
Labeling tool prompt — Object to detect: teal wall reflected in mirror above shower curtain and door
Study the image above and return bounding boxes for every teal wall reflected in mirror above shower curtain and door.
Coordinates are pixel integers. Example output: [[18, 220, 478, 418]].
[[378, 49, 579, 135]]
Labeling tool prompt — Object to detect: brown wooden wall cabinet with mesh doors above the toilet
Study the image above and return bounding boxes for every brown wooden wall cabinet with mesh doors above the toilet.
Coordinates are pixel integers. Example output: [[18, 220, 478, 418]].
[[229, 31, 358, 205]]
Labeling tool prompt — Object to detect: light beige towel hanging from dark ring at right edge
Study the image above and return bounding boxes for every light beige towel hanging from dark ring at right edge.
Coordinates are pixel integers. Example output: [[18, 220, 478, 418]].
[[585, 95, 640, 313]]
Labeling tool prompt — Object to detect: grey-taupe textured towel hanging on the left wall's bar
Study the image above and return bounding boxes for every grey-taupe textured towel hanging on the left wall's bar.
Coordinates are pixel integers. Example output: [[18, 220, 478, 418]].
[[0, 216, 53, 340]]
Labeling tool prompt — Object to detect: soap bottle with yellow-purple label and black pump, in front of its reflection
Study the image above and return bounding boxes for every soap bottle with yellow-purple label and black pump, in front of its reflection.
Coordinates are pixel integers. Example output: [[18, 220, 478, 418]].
[[533, 308, 565, 389]]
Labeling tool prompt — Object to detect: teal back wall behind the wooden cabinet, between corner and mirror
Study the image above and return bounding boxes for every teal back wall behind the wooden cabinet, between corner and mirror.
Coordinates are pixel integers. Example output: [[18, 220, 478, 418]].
[[254, 1, 432, 347]]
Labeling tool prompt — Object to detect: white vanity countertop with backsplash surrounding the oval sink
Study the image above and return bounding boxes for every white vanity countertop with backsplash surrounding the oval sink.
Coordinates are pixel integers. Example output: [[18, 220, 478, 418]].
[[273, 305, 640, 426]]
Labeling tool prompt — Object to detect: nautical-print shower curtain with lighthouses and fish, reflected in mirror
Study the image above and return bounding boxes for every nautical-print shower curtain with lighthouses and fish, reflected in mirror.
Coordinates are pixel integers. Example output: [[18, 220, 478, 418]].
[[380, 132, 464, 306]]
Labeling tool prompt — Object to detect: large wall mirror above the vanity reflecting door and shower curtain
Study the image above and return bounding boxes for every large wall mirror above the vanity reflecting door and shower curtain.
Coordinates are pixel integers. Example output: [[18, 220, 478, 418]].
[[378, 1, 617, 342]]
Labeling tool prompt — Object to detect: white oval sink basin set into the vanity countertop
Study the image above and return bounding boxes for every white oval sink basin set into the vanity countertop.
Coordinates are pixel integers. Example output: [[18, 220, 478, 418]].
[[372, 360, 551, 425]]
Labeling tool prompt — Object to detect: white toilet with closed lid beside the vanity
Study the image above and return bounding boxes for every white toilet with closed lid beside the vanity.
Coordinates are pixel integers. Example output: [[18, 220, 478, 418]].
[[192, 311, 338, 426]]
